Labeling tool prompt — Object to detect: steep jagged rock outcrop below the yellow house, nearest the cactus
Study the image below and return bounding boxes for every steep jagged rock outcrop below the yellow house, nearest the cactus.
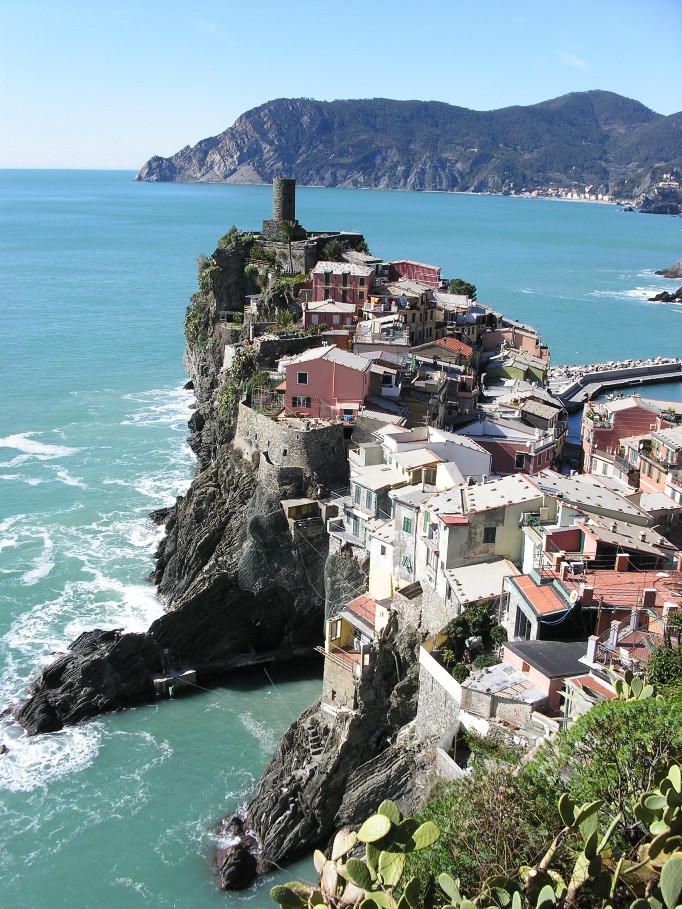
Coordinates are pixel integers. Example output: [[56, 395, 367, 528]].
[[219, 635, 420, 889]]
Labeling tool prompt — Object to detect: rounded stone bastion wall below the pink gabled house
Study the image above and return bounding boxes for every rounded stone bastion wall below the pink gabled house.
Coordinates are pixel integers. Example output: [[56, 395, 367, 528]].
[[234, 403, 347, 486]]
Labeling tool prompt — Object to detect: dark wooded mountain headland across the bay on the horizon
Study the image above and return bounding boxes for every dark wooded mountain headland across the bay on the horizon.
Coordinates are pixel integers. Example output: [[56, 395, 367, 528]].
[[137, 91, 682, 196]]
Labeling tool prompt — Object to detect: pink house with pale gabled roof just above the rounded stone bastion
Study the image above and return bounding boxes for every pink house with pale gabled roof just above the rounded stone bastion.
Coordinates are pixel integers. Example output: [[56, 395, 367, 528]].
[[279, 347, 372, 420]]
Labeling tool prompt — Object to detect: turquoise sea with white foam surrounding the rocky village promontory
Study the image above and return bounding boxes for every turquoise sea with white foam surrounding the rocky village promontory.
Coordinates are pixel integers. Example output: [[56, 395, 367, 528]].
[[0, 170, 682, 909]]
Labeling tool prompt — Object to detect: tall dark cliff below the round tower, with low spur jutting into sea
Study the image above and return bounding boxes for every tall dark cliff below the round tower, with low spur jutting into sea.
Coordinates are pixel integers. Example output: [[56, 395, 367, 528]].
[[15, 232, 334, 734]]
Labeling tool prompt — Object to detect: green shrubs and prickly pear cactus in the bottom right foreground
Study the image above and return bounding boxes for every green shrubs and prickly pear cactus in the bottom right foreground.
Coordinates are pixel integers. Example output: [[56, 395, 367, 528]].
[[272, 680, 682, 909]]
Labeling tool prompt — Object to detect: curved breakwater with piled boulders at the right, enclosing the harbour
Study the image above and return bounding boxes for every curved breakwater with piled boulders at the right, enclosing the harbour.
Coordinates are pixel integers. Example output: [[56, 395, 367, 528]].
[[548, 357, 682, 411]]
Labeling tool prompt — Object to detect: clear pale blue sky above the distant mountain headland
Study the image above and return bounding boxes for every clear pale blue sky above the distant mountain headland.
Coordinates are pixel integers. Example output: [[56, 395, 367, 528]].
[[0, 0, 682, 170]]
